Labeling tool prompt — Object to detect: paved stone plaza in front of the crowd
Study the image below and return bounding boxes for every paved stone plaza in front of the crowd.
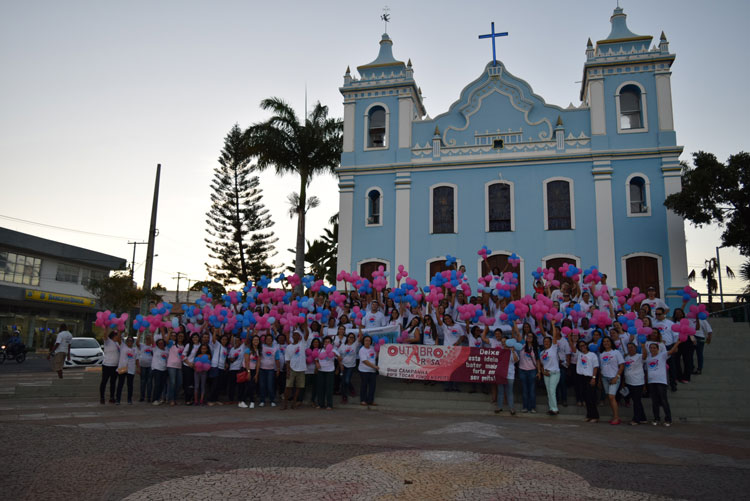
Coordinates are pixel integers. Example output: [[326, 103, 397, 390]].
[[0, 366, 750, 500]]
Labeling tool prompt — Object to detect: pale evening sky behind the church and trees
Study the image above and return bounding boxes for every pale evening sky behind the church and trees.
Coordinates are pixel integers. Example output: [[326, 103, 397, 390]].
[[0, 0, 750, 292]]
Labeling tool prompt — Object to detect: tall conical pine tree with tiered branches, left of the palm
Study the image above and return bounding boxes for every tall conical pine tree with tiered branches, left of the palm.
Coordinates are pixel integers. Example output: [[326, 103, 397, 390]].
[[205, 124, 278, 285]]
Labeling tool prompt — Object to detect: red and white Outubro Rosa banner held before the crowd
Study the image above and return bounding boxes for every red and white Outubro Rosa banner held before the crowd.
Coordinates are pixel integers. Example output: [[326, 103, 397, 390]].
[[378, 344, 510, 384]]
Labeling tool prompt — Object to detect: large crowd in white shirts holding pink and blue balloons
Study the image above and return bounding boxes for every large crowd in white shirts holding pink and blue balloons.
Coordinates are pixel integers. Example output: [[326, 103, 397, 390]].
[[95, 267, 712, 426]]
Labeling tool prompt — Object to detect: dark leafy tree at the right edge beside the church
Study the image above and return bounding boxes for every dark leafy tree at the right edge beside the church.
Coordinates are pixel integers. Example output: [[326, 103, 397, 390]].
[[664, 151, 750, 256]]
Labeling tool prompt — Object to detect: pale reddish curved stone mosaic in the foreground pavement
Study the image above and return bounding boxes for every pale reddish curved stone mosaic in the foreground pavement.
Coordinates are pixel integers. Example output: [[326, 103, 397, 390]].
[[126, 451, 667, 501]]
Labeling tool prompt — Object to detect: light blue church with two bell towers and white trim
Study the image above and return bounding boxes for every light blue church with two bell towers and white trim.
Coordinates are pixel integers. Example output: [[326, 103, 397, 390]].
[[338, 7, 687, 306]]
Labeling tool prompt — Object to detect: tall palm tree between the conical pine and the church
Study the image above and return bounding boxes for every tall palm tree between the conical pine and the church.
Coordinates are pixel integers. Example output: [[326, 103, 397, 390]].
[[246, 97, 343, 292]]
